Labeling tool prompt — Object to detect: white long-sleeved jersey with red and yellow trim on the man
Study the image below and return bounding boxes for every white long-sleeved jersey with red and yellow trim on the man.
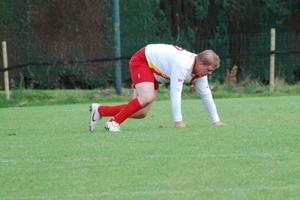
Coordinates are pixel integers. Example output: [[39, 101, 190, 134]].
[[145, 44, 220, 123]]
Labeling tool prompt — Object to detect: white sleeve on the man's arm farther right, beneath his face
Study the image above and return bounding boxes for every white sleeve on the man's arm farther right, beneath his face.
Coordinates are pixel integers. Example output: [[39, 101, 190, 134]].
[[194, 76, 220, 123]]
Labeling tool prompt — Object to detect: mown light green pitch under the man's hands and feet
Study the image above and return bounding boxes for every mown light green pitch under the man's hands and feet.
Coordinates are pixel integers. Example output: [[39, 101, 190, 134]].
[[0, 96, 300, 200]]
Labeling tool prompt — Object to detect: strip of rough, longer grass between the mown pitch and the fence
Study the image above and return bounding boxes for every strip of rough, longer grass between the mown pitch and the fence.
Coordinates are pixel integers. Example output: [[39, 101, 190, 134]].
[[0, 81, 300, 108]]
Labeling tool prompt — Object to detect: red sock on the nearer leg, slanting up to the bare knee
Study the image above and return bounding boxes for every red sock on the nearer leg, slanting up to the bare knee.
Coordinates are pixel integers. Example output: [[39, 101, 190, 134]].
[[113, 98, 143, 124]]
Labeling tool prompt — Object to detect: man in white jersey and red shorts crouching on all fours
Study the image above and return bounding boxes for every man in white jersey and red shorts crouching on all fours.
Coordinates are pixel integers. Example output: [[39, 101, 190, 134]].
[[90, 44, 225, 132]]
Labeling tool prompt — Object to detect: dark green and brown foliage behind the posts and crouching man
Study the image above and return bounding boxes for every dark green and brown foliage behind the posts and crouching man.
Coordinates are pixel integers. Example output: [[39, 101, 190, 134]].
[[0, 0, 300, 89]]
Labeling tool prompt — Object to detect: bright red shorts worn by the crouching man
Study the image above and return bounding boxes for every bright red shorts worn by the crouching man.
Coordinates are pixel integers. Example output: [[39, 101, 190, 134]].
[[129, 47, 159, 90]]
